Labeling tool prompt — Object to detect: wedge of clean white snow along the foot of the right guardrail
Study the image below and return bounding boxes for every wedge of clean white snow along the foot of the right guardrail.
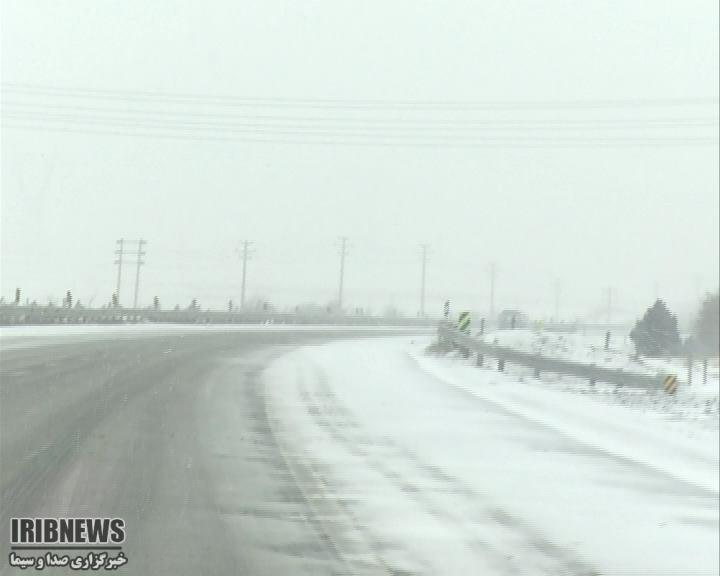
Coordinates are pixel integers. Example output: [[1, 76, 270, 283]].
[[411, 342, 720, 492]]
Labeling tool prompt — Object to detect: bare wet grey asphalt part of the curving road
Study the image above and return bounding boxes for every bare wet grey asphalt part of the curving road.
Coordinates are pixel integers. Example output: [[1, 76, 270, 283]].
[[0, 331, 420, 575]]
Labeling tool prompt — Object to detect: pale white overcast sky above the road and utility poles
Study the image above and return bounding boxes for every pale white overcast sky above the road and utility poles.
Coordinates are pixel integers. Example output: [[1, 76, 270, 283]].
[[1, 0, 719, 318]]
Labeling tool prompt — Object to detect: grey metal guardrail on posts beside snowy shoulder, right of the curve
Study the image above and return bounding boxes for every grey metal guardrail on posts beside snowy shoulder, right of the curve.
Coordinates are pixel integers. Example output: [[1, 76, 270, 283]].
[[438, 322, 674, 393]]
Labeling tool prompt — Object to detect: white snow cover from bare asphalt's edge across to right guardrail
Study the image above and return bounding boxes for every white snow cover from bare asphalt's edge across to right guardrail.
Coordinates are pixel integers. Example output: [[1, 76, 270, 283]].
[[264, 336, 720, 576]]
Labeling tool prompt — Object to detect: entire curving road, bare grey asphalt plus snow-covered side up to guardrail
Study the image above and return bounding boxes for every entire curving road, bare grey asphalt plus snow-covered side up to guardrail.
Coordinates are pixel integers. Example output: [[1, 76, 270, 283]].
[[0, 330, 719, 576]]
